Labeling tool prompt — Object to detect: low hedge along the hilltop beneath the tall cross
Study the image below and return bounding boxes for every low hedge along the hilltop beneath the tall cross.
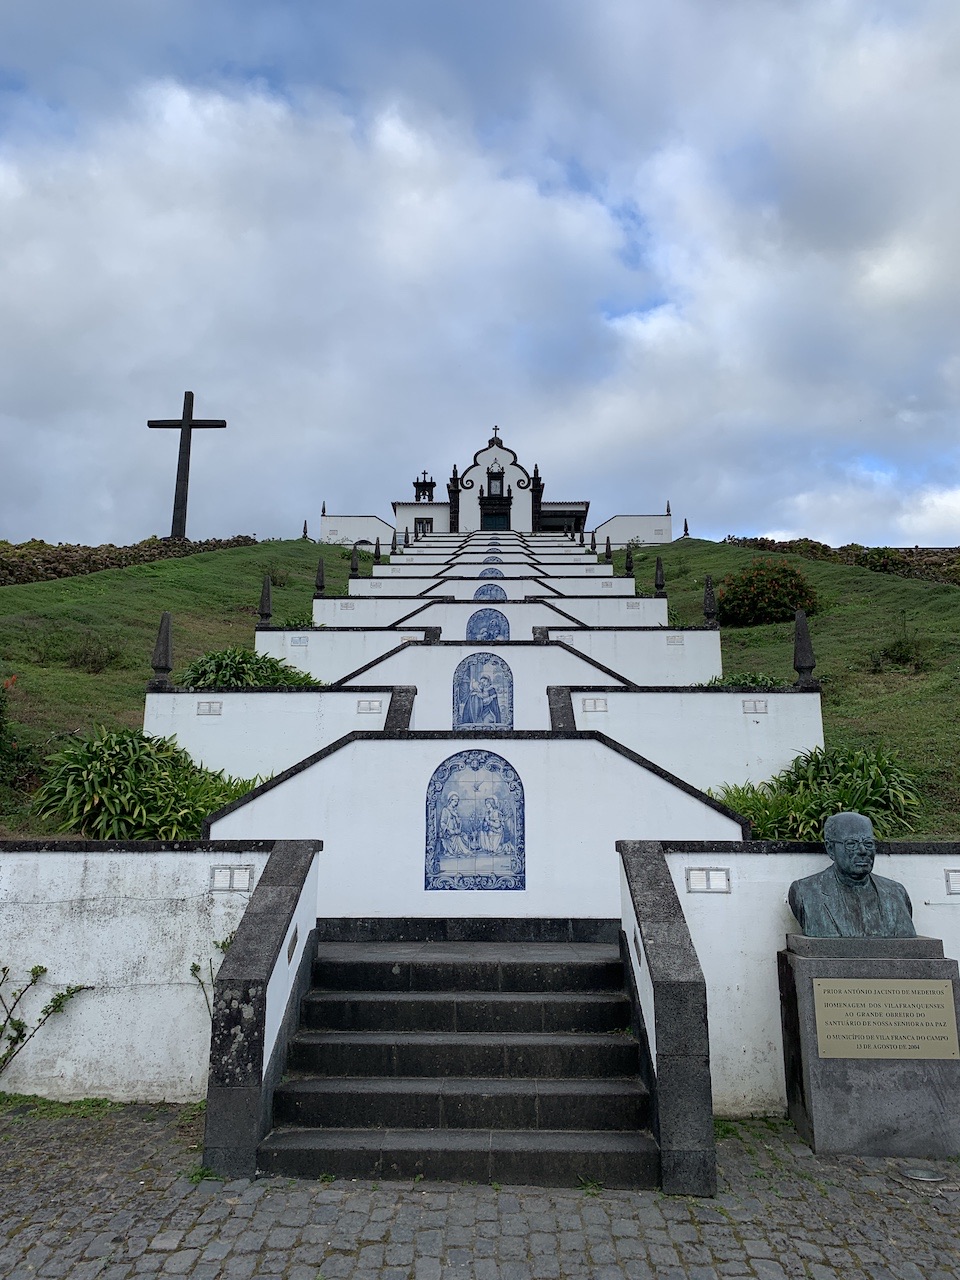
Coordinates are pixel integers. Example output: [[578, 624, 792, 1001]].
[[0, 534, 256, 586]]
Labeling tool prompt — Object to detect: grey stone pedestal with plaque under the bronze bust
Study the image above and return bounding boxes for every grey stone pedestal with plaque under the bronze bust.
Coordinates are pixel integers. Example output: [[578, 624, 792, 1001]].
[[777, 934, 960, 1158]]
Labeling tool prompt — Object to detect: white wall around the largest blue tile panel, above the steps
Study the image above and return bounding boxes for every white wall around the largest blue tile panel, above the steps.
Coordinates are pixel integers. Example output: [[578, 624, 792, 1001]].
[[204, 736, 740, 919]]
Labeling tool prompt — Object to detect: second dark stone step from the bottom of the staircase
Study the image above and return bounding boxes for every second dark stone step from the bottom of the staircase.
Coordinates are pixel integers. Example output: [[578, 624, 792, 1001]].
[[268, 1076, 650, 1130]]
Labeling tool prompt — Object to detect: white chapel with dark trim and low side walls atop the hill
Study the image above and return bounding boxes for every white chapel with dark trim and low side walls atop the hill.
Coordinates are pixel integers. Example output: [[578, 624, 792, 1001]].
[[320, 428, 673, 547]]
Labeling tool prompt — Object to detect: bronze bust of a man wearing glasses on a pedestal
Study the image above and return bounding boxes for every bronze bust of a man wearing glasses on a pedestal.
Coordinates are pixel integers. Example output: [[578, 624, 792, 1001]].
[[787, 813, 916, 938]]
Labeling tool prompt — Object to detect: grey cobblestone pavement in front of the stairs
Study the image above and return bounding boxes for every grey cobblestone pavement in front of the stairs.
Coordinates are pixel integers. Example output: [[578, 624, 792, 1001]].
[[0, 1105, 960, 1280]]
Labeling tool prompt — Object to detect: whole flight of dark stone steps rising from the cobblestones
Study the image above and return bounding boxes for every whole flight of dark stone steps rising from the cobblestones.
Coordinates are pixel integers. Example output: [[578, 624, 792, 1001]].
[[257, 920, 659, 1187]]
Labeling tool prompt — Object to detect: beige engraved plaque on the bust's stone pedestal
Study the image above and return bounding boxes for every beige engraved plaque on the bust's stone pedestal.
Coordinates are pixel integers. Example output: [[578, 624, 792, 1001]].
[[813, 978, 960, 1059]]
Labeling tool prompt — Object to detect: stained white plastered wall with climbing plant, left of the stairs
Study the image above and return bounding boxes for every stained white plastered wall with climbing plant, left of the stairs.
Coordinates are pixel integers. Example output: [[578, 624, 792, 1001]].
[[0, 845, 268, 1102]]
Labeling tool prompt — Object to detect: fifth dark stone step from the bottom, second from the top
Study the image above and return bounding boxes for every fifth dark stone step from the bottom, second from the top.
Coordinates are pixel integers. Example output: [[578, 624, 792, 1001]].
[[314, 942, 623, 992]]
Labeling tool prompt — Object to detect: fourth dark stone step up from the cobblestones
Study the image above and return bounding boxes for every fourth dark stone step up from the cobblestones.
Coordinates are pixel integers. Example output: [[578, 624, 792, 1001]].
[[301, 991, 630, 1033]]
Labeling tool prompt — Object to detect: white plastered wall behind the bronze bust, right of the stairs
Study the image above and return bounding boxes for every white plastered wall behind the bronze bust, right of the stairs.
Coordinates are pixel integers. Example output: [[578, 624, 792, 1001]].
[[667, 846, 960, 1116]]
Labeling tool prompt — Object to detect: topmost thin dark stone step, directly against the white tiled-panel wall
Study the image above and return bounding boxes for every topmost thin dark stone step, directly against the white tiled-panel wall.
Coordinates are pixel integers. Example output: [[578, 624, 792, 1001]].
[[316, 916, 620, 946]]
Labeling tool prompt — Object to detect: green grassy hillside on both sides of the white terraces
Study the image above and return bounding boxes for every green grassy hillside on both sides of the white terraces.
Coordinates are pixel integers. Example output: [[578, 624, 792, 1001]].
[[0, 539, 960, 840]]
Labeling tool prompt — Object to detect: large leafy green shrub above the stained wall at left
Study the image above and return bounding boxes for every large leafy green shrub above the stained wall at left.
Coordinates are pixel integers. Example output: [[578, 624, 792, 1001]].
[[33, 728, 259, 840]]
